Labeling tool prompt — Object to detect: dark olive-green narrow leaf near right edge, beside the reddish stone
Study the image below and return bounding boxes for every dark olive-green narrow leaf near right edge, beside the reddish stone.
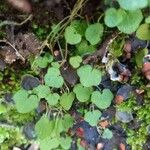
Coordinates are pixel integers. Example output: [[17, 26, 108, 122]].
[[135, 48, 148, 68]]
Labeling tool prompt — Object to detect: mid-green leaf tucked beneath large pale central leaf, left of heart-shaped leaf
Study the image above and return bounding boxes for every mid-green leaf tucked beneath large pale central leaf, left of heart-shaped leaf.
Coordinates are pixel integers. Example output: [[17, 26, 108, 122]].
[[73, 84, 93, 102]]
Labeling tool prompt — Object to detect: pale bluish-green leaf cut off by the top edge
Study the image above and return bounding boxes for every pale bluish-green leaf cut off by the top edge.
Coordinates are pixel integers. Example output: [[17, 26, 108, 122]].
[[118, 0, 148, 10]]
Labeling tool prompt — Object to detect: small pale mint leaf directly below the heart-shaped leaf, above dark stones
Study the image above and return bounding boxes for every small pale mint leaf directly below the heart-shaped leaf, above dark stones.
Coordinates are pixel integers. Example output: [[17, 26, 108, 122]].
[[84, 110, 101, 126]]
